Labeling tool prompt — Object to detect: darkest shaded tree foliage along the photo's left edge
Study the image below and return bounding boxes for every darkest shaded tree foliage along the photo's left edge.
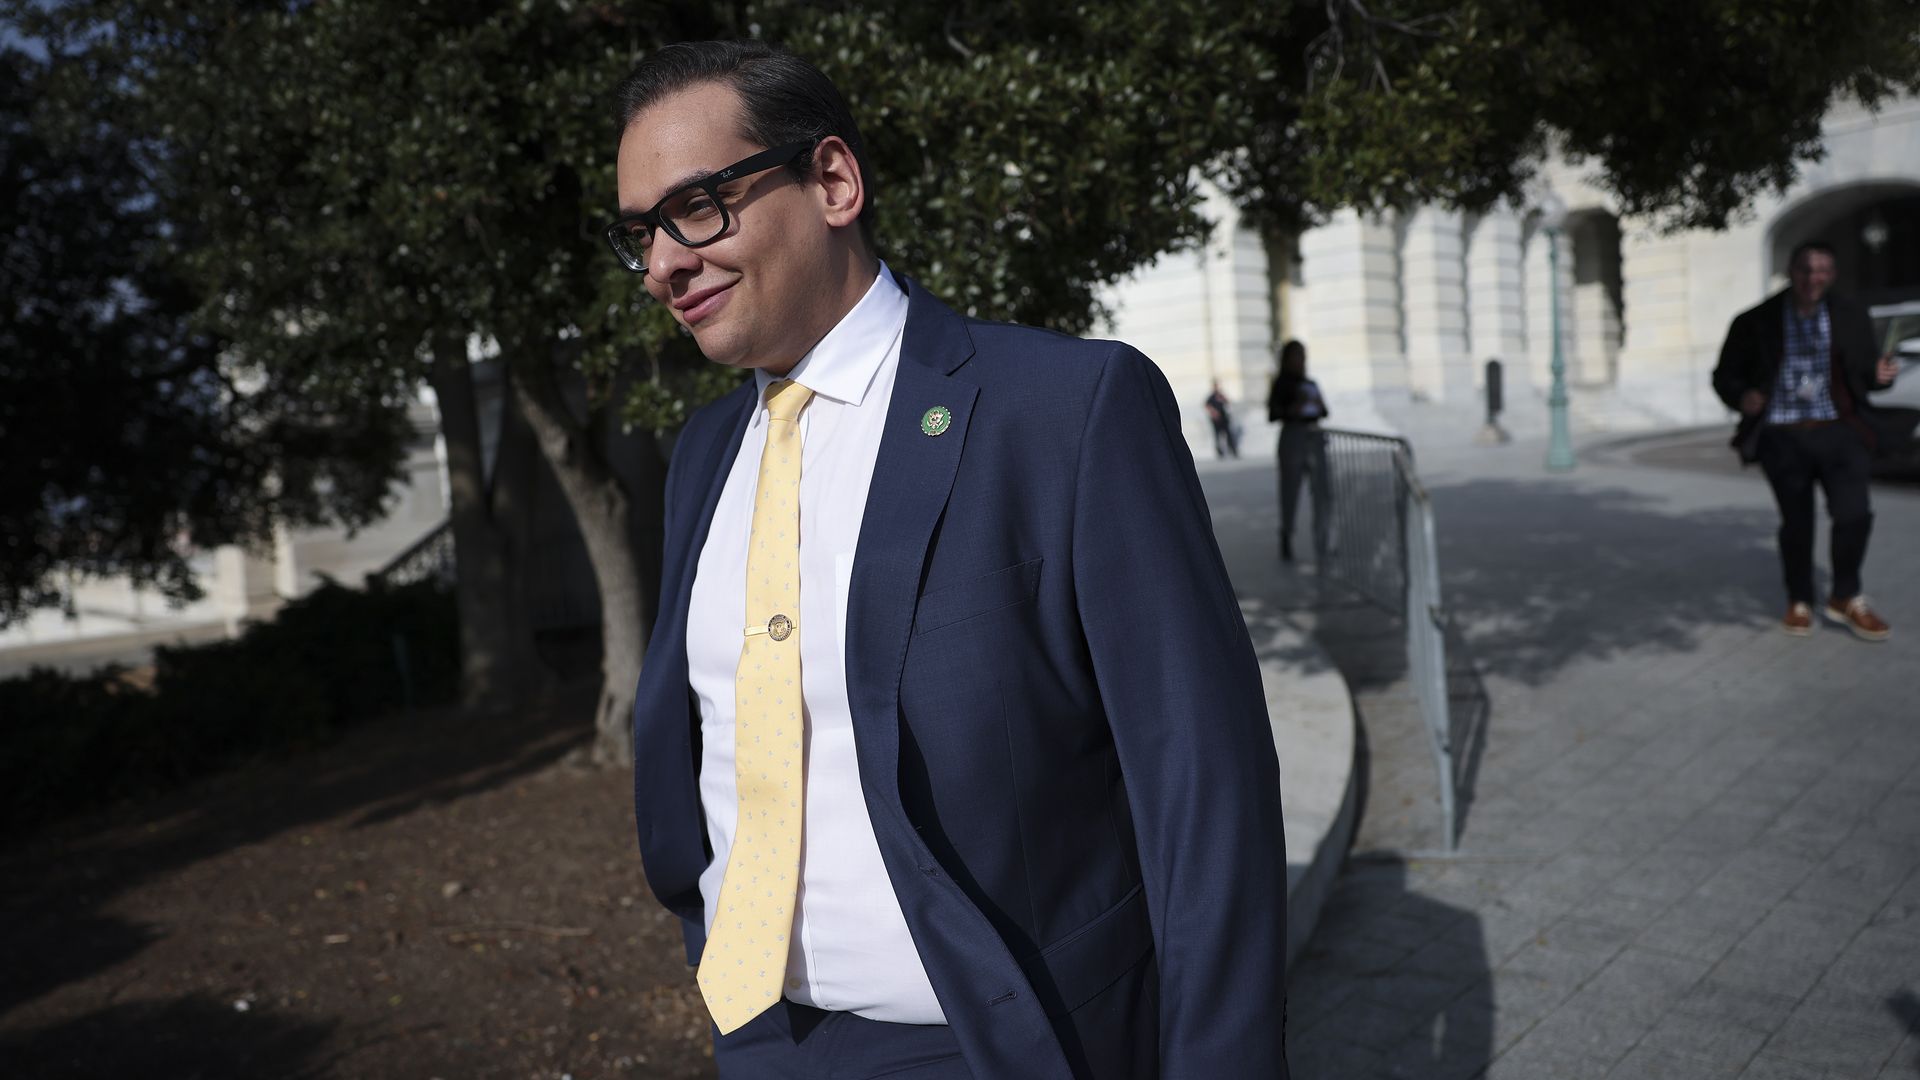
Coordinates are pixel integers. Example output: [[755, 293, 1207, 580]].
[[0, 50, 411, 625]]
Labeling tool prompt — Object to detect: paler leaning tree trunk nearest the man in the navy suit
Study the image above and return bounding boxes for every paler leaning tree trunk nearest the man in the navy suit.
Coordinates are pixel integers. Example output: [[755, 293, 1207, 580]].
[[511, 357, 655, 765]]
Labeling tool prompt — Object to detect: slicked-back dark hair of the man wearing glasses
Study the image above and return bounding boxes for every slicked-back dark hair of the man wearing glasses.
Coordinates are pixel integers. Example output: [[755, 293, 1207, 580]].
[[614, 40, 874, 246]]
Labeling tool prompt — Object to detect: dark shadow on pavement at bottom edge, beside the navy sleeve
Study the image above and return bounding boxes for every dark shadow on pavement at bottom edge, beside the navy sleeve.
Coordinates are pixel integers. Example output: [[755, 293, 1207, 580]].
[[1288, 855, 1496, 1080]]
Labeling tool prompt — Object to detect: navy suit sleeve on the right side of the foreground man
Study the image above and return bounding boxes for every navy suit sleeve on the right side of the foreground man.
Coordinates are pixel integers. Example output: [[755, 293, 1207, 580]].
[[1073, 346, 1286, 1080]]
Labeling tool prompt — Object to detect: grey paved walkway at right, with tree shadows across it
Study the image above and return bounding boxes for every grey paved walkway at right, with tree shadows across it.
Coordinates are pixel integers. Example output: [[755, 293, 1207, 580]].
[[1202, 418, 1920, 1080]]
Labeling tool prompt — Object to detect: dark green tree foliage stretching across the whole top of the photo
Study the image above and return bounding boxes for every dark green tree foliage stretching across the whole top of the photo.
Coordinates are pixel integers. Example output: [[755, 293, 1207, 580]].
[[15, 0, 1920, 715]]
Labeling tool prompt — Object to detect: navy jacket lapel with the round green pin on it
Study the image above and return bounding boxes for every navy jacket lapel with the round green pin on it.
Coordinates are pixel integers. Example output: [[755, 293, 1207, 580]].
[[845, 279, 979, 795]]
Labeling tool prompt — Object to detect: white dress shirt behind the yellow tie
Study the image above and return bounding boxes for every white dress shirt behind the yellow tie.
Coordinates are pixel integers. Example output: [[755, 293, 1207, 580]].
[[687, 263, 947, 1024]]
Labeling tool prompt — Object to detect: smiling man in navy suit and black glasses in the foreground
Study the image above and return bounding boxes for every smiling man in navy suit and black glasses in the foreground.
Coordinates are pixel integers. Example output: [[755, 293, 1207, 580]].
[[607, 42, 1286, 1080]]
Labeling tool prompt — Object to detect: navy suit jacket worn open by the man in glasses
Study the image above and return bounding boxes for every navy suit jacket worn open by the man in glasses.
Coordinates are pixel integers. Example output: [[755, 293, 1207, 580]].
[[634, 279, 1286, 1080]]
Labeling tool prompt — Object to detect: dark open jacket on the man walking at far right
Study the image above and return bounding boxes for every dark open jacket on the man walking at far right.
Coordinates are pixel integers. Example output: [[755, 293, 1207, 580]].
[[1713, 290, 1891, 461]]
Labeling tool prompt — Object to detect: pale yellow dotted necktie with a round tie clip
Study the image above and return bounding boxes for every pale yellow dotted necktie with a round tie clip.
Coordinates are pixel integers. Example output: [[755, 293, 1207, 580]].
[[697, 380, 814, 1034]]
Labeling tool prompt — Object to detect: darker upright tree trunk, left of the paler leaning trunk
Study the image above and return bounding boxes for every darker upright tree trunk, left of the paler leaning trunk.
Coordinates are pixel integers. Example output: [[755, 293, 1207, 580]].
[[428, 336, 538, 705]]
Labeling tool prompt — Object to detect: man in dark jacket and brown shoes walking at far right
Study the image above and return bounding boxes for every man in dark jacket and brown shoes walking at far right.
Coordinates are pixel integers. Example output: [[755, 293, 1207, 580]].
[[1713, 242, 1899, 642]]
